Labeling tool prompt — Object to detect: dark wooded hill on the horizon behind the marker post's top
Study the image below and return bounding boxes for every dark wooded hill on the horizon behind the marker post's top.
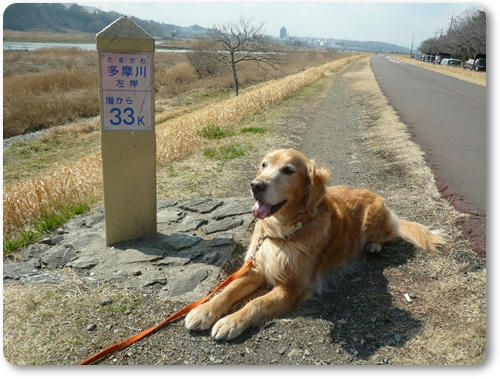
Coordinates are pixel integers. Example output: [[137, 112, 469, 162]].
[[3, 3, 208, 38]]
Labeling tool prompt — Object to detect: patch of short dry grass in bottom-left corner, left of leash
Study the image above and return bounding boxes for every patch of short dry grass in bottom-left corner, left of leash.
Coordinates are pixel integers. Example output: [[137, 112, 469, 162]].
[[3, 269, 148, 365]]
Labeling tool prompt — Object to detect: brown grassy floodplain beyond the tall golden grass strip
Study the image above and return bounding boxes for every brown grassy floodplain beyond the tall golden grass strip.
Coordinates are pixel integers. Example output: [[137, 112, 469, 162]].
[[3, 44, 348, 138]]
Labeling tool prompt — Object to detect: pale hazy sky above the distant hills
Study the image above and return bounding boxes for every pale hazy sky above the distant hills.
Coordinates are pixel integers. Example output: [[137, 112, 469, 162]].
[[78, 1, 482, 48]]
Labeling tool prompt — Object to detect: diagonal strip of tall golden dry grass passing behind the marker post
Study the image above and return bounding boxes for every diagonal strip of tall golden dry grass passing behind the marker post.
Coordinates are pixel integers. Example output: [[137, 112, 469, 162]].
[[3, 57, 356, 246]]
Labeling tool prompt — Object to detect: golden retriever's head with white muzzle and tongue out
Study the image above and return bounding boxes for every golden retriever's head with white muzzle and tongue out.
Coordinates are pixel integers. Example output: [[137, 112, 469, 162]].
[[250, 149, 330, 219]]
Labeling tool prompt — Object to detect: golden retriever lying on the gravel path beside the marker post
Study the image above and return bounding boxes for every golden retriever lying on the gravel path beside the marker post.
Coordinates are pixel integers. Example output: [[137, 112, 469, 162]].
[[185, 149, 443, 340]]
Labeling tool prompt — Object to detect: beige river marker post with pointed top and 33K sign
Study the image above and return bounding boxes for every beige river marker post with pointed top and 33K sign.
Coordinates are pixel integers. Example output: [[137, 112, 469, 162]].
[[96, 17, 157, 245]]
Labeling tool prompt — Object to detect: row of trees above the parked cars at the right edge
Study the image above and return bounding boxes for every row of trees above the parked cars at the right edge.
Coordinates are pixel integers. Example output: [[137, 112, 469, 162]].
[[419, 9, 486, 61]]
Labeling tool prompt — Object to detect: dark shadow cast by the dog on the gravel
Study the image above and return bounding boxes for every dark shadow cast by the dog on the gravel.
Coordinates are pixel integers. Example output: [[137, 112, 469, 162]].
[[221, 240, 422, 360]]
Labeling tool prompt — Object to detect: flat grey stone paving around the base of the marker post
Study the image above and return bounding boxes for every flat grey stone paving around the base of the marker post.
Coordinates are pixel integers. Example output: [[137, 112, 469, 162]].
[[3, 198, 253, 301]]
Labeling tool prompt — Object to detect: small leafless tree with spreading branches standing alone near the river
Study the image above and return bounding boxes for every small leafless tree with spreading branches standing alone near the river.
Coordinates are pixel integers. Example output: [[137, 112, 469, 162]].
[[210, 17, 280, 96]]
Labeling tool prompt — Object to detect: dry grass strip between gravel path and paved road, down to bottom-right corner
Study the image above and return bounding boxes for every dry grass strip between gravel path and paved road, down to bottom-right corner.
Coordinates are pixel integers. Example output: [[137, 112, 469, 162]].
[[346, 56, 486, 365]]
